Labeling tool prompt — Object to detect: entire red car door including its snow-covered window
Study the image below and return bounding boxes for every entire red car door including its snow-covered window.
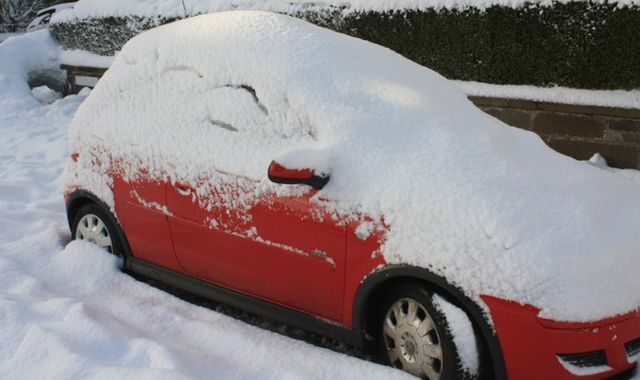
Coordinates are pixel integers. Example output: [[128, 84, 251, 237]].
[[166, 79, 345, 320]]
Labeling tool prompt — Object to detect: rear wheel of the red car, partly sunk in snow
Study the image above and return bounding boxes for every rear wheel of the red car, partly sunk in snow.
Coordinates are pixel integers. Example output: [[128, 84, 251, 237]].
[[71, 203, 126, 259]]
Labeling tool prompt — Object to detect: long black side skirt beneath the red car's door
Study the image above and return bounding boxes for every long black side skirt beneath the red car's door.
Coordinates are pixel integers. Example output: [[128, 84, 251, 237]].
[[125, 256, 364, 348]]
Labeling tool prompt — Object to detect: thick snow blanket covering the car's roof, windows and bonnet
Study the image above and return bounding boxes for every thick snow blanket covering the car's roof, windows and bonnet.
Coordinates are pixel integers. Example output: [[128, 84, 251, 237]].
[[67, 11, 640, 321]]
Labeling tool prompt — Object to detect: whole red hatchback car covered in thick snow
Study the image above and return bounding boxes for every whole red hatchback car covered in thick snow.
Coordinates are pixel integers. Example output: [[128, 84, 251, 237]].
[[65, 12, 640, 379]]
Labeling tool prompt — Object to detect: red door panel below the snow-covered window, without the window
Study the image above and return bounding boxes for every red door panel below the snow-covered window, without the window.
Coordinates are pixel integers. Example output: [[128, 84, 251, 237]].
[[167, 175, 346, 320]]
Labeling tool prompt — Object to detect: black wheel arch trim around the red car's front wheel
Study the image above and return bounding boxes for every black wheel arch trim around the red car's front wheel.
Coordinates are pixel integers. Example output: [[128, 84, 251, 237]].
[[353, 265, 507, 379]]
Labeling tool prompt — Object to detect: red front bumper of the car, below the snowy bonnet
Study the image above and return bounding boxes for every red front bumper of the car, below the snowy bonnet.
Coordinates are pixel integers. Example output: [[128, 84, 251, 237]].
[[482, 296, 640, 380]]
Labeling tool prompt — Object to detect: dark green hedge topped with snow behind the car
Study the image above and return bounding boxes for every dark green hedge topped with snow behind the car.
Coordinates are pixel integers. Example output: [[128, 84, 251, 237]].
[[51, 1, 640, 89]]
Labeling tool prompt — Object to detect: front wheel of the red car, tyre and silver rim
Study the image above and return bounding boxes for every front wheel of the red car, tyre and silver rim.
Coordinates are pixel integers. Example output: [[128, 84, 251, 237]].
[[376, 283, 469, 380]]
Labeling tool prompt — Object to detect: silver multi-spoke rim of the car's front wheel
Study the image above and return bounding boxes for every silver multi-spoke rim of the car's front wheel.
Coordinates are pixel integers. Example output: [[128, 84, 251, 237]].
[[382, 298, 443, 380]]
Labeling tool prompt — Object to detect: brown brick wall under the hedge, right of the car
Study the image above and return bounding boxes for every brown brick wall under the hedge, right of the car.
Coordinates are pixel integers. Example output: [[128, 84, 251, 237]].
[[470, 97, 640, 169]]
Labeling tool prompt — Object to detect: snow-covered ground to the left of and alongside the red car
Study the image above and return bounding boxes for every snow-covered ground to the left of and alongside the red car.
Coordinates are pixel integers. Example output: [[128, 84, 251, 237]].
[[0, 31, 410, 380]]
